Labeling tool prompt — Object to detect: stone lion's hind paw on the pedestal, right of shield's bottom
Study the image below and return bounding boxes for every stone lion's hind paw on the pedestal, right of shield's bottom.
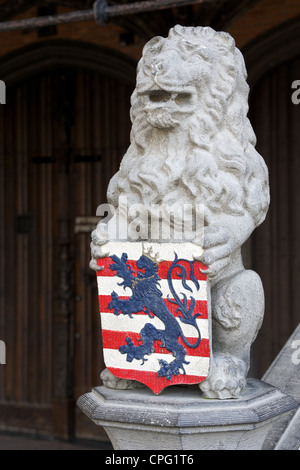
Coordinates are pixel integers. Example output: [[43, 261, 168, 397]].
[[199, 355, 246, 400]]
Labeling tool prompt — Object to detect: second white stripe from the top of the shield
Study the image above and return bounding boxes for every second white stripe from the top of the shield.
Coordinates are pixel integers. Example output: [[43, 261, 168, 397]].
[[97, 275, 207, 300]]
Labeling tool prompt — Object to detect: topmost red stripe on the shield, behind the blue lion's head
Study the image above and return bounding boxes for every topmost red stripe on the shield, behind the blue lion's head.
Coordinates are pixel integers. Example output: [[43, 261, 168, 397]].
[[97, 257, 207, 281]]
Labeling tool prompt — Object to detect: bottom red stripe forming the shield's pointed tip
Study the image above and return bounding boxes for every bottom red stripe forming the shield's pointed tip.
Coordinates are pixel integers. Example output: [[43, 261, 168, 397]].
[[108, 367, 206, 395]]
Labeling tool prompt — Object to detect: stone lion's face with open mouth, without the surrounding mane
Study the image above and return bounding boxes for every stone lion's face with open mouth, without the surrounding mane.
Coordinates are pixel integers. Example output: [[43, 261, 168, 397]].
[[136, 32, 214, 129]]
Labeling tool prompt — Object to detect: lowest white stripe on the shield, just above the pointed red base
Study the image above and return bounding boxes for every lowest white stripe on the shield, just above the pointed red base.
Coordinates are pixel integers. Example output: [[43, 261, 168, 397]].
[[103, 349, 209, 376]]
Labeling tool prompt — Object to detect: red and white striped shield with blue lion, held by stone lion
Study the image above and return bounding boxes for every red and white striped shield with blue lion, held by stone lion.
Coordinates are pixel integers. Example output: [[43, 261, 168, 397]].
[[97, 241, 211, 394]]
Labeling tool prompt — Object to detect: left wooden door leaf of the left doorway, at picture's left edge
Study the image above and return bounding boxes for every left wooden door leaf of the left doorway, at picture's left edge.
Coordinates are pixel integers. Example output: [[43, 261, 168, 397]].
[[0, 72, 53, 432]]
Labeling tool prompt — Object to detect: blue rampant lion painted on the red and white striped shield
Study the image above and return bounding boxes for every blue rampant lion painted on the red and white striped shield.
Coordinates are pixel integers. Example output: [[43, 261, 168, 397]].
[[108, 253, 201, 381]]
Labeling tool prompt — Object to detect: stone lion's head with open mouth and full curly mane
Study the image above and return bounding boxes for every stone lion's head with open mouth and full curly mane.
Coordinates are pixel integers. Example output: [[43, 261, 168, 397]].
[[108, 26, 269, 229]]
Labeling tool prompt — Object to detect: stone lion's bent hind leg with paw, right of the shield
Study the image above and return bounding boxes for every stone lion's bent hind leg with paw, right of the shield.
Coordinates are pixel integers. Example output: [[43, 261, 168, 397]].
[[200, 270, 264, 399]]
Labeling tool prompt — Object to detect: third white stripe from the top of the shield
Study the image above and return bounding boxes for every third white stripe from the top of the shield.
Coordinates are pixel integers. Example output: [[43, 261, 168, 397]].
[[101, 312, 209, 338]]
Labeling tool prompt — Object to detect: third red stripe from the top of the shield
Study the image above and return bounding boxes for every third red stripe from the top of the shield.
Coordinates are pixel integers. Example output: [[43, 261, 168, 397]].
[[102, 330, 210, 357]]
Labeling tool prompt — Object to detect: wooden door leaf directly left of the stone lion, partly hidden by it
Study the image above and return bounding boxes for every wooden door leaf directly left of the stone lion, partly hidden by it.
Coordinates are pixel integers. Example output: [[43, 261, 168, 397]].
[[72, 72, 131, 437]]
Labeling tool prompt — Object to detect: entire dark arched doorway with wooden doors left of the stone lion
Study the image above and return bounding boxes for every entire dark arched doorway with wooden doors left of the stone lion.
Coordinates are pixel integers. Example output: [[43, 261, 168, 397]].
[[0, 43, 135, 438]]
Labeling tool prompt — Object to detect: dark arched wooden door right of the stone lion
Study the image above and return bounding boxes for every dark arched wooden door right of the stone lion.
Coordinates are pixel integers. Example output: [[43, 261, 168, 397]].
[[250, 57, 300, 377]]
